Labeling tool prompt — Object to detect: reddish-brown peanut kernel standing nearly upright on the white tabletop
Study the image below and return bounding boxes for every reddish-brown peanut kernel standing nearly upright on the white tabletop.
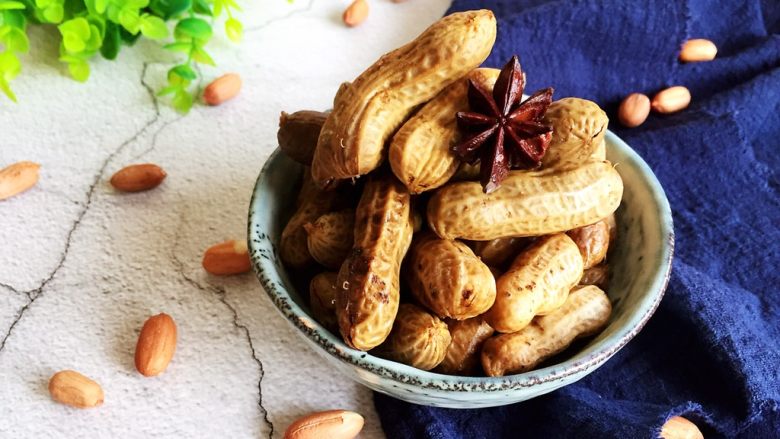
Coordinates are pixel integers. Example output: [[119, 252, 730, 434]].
[[135, 314, 176, 377]]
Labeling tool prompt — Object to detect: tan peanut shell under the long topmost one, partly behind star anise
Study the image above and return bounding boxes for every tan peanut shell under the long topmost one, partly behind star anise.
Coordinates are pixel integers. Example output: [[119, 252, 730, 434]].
[[388, 69, 500, 194]]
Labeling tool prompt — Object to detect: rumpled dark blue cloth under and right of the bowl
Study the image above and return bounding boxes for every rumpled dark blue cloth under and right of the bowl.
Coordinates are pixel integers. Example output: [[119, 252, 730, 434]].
[[375, 0, 780, 438]]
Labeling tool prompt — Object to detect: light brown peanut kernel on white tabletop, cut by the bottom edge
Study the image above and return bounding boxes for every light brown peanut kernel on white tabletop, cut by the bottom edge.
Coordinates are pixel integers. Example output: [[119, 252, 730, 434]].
[[284, 410, 363, 439]]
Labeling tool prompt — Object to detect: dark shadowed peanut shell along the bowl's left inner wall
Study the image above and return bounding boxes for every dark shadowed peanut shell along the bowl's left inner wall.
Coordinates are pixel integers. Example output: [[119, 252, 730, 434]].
[[279, 171, 339, 268]]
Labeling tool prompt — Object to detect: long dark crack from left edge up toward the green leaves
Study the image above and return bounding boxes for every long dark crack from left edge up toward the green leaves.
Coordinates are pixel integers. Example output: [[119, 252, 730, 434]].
[[0, 63, 160, 353]]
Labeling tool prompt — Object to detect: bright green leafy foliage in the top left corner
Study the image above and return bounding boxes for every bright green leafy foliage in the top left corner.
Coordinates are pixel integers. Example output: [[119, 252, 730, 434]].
[[0, 0, 250, 113]]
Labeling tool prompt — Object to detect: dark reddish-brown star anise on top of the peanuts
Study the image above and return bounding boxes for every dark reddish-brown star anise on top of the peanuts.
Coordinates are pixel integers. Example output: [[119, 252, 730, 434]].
[[452, 56, 553, 194]]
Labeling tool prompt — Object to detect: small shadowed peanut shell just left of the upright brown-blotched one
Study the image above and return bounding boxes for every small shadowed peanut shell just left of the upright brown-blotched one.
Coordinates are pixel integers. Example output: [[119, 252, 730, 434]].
[[303, 209, 355, 270]]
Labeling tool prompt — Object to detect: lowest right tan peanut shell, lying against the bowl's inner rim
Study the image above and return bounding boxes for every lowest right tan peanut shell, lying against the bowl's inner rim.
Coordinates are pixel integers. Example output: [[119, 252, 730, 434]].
[[482, 285, 612, 376]]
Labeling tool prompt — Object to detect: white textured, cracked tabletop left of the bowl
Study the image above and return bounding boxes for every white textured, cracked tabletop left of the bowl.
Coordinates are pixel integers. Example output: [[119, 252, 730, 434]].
[[0, 0, 449, 438]]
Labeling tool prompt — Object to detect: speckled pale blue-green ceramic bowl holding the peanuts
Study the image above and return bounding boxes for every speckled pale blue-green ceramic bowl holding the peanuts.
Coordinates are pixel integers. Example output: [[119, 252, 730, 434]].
[[248, 132, 674, 408]]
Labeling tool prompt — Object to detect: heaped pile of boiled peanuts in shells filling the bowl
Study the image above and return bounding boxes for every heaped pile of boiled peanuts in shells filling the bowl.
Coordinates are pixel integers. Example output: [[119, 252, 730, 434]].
[[278, 10, 623, 376]]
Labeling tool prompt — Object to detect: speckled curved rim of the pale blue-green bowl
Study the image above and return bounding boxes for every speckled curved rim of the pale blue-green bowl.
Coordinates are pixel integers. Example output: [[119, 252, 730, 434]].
[[247, 130, 674, 392]]
